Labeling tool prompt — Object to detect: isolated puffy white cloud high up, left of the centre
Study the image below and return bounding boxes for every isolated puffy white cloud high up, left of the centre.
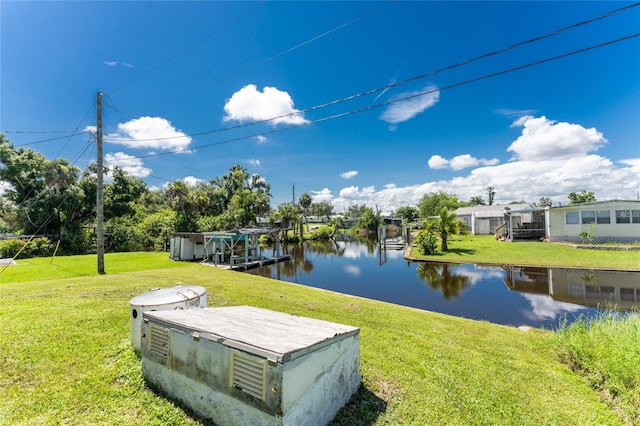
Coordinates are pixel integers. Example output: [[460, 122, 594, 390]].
[[223, 84, 309, 126]]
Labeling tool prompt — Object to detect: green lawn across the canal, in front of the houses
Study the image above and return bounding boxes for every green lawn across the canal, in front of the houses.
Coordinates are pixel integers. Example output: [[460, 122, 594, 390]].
[[411, 235, 640, 271]]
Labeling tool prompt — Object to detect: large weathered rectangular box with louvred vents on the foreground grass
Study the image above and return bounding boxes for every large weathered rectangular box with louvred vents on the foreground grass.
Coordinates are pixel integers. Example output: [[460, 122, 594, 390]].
[[141, 306, 360, 426]]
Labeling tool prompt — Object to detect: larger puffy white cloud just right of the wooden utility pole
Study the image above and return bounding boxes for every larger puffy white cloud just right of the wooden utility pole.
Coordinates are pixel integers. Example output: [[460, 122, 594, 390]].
[[104, 117, 191, 152]]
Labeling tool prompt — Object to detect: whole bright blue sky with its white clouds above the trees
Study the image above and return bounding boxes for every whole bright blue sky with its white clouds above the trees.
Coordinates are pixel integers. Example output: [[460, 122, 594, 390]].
[[0, 0, 640, 212]]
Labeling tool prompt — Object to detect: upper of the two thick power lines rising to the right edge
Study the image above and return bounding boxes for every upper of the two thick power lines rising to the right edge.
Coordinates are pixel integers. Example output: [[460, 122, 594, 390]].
[[100, 3, 640, 146]]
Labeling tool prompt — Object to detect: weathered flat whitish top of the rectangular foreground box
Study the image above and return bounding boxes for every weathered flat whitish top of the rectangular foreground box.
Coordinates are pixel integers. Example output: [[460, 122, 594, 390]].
[[144, 306, 360, 362]]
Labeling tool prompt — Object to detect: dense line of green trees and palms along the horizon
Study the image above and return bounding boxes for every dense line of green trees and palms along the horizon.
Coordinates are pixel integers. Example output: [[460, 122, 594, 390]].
[[0, 133, 595, 254]]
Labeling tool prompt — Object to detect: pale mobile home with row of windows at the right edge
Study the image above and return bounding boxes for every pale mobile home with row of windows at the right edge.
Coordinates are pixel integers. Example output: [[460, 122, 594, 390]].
[[545, 200, 640, 244]]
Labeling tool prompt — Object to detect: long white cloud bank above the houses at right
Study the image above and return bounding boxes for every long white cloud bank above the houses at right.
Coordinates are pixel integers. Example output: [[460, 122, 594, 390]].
[[314, 116, 640, 213]]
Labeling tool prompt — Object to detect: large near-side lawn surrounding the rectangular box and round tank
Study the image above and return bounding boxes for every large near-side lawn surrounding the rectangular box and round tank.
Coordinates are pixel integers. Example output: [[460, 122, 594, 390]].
[[0, 254, 624, 425]]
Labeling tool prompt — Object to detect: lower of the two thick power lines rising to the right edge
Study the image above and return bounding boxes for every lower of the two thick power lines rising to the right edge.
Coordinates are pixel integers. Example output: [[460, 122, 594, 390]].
[[124, 33, 640, 159]]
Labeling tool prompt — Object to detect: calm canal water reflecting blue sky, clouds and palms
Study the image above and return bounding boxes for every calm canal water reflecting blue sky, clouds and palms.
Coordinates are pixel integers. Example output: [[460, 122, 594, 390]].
[[247, 241, 640, 329]]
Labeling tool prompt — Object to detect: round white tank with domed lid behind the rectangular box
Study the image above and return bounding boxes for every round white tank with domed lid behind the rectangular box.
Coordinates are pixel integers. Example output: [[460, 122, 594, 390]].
[[129, 284, 207, 350]]
